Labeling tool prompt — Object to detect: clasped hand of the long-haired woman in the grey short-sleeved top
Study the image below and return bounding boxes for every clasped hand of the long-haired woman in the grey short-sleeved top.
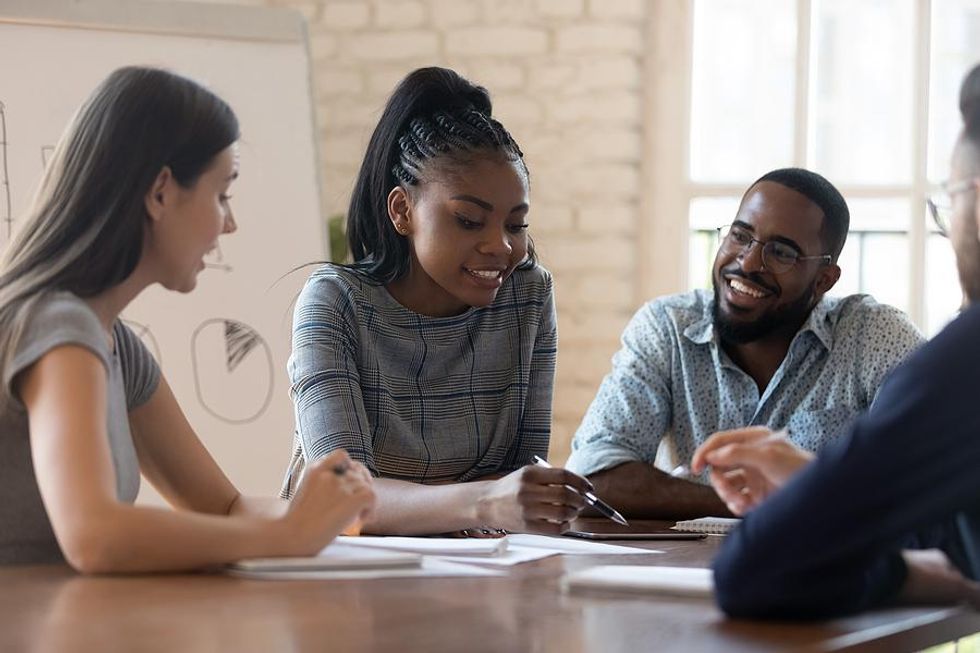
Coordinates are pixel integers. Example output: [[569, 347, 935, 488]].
[[283, 450, 374, 555]]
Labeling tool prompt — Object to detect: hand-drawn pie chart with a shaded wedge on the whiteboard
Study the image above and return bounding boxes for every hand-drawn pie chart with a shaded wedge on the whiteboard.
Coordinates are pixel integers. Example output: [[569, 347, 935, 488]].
[[191, 318, 274, 424]]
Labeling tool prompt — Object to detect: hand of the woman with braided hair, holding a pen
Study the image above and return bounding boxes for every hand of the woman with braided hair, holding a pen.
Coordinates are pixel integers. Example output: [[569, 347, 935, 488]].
[[477, 465, 592, 535]]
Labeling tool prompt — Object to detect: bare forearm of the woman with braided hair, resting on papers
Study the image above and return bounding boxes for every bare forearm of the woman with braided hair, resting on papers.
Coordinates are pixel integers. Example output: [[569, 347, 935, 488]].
[[361, 478, 493, 535]]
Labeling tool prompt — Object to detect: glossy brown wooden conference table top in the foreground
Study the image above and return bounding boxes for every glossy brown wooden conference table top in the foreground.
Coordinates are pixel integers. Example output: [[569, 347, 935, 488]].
[[0, 520, 980, 653]]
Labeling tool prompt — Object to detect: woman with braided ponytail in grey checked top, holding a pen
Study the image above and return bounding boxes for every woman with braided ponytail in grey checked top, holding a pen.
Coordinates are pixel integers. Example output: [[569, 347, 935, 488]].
[[283, 68, 590, 535]]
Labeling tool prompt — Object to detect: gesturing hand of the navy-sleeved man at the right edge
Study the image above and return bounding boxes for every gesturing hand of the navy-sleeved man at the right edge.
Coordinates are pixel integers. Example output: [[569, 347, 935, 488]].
[[691, 426, 814, 515]]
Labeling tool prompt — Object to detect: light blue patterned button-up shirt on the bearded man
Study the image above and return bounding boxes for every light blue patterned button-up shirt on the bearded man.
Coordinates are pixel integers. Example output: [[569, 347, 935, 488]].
[[567, 290, 923, 483]]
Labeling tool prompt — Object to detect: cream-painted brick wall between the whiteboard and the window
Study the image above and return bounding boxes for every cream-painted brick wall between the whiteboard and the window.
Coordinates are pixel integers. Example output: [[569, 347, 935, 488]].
[[222, 0, 649, 460]]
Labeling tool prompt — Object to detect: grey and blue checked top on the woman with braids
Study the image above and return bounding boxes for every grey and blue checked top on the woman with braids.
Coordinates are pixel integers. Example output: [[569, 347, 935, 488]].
[[287, 264, 557, 482]]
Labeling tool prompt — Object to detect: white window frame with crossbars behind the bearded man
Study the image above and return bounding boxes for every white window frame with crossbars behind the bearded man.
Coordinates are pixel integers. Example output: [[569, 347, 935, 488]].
[[638, 0, 933, 330]]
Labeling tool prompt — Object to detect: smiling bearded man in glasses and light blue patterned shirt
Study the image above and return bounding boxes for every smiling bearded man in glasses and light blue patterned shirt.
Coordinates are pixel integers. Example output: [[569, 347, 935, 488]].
[[567, 168, 922, 519]]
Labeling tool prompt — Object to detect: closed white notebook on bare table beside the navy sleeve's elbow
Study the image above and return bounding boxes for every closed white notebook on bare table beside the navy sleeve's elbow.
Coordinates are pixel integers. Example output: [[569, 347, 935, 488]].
[[561, 565, 714, 597]]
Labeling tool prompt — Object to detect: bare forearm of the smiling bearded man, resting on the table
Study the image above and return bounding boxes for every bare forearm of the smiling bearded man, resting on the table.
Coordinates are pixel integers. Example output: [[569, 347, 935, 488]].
[[589, 462, 731, 519]]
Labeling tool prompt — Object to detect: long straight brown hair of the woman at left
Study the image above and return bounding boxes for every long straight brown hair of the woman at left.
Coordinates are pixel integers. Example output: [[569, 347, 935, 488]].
[[0, 67, 238, 409]]
